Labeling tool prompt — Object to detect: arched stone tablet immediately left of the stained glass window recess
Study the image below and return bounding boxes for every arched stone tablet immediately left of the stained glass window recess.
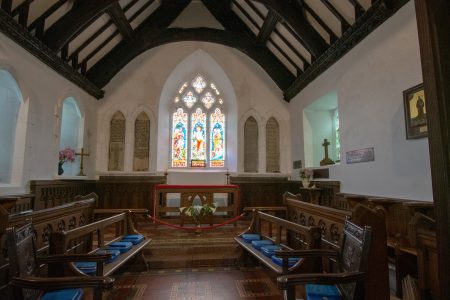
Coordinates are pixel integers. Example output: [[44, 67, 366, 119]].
[[133, 112, 150, 171]]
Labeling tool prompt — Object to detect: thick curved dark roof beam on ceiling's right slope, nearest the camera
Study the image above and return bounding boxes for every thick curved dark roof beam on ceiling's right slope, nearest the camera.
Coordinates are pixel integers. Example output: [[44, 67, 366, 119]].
[[251, 0, 328, 57]]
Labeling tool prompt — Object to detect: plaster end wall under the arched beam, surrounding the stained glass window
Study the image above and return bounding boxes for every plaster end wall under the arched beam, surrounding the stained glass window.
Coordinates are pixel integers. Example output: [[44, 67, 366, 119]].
[[96, 42, 291, 178]]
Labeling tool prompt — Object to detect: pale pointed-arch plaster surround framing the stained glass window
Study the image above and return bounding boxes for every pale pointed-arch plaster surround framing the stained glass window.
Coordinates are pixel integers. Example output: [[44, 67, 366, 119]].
[[157, 49, 238, 172]]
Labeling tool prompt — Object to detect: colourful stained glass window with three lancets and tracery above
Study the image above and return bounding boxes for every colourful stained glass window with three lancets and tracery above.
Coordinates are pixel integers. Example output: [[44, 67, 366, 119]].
[[171, 75, 226, 168]]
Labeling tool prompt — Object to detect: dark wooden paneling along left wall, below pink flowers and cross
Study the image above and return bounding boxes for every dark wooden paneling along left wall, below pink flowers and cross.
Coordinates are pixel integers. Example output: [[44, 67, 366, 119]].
[[30, 180, 95, 210]]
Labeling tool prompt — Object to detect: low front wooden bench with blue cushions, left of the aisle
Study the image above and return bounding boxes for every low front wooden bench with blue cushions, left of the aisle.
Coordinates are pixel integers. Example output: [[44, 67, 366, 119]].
[[50, 211, 151, 276]]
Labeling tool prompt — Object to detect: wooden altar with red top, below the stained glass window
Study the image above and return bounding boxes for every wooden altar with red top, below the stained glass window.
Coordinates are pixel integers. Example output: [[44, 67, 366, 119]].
[[153, 184, 240, 225]]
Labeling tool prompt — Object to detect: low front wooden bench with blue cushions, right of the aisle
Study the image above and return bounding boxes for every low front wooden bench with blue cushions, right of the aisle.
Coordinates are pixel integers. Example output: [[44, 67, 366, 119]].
[[234, 210, 320, 274]]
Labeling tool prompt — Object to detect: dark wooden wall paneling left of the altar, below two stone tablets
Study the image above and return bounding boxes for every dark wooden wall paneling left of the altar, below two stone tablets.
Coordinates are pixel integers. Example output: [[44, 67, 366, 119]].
[[97, 176, 167, 213]]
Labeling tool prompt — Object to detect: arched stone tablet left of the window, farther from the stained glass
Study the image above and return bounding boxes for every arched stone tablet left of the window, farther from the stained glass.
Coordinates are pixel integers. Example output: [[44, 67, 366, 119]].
[[108, 111, 126, 171]]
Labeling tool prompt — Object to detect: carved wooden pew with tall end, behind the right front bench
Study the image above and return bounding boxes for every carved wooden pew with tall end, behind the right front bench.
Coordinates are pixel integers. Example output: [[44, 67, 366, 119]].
[[284, 193, 389, 300]]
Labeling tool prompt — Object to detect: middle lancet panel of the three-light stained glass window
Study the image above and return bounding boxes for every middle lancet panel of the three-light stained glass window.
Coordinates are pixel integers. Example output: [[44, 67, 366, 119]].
[[191, 108, 206, 167]]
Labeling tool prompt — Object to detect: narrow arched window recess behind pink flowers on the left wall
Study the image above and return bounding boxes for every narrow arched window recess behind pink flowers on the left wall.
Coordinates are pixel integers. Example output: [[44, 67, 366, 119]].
[[58, 97, 84, 176]]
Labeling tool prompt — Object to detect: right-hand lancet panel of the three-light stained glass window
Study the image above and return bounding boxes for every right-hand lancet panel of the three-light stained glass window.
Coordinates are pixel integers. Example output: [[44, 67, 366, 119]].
[[209, 108, 225, 167]]
